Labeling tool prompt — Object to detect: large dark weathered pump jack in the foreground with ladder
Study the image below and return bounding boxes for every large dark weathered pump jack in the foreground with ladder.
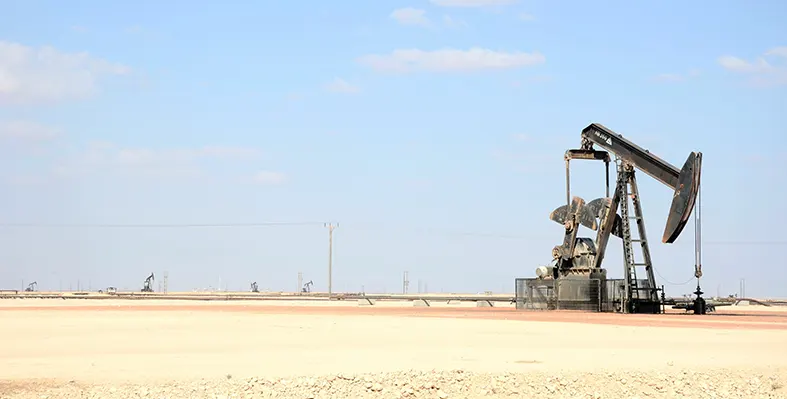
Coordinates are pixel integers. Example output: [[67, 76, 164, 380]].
[[536, 123, 705, 314]]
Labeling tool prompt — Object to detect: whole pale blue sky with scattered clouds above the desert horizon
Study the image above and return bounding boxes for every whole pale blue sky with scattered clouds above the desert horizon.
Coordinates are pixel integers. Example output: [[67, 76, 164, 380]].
[[0, 0, 787, 296]]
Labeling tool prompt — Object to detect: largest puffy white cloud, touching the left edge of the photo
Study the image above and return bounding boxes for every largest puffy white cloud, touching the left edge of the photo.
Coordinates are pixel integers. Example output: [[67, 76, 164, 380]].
[[0, 41, 131, 104]]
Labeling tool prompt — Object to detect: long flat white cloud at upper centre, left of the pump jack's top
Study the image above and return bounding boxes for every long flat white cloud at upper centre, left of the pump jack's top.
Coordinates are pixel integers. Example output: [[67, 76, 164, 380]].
[[357, 47, 546, 73]]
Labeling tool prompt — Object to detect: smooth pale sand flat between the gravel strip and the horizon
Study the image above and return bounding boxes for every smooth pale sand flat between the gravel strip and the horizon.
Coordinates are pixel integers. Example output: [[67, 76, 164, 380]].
[[0, 299, 787, 397]]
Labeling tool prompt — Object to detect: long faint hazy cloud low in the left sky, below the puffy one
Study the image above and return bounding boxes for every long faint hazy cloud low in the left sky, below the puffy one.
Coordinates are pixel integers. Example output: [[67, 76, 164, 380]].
[[54, 142, 261, 177]]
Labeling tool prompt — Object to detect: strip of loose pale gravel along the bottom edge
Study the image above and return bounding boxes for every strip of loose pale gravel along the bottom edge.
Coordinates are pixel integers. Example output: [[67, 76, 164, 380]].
[[0, 369, 787, 399]]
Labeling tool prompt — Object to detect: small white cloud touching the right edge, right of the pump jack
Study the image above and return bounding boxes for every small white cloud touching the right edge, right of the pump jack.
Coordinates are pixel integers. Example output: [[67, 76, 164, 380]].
[[718, 47, 787, 86]]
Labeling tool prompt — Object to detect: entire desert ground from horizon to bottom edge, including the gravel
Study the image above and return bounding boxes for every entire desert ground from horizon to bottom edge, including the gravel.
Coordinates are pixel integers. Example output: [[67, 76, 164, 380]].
[[0, 299, 787, 398]]
